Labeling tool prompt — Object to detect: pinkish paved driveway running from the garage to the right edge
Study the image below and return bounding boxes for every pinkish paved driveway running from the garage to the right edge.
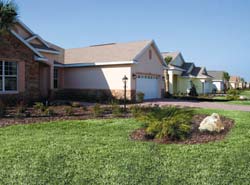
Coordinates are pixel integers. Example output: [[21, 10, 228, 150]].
[[143, 99, 250, 112]]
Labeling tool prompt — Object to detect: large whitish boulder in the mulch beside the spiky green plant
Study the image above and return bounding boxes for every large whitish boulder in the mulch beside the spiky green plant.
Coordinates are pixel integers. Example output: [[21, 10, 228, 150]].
[[199, 113, 224, 132]]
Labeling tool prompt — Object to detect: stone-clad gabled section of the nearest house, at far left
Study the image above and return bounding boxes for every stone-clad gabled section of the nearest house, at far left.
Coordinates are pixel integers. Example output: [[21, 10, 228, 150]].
[[0, 20, 60, 100]]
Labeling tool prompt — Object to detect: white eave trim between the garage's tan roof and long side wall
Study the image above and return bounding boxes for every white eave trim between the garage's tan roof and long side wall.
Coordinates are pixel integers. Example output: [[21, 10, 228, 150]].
[[54, 61, 137, 67]]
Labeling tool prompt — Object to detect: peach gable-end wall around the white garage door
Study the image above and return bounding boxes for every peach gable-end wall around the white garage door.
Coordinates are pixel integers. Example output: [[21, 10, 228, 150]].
[[131, 46, 165, 97]]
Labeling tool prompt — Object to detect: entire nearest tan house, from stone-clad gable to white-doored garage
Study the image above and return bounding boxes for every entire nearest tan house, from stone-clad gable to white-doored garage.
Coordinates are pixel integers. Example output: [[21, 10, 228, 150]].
[[0, 20, 166, 100]]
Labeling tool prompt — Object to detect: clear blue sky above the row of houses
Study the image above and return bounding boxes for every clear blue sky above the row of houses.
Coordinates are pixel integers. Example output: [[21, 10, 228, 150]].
[[15, 0, 250, 81]]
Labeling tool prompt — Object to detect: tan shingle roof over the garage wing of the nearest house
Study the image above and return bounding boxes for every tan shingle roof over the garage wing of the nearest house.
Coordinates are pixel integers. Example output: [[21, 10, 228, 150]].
[[65, 40, 153, 64]]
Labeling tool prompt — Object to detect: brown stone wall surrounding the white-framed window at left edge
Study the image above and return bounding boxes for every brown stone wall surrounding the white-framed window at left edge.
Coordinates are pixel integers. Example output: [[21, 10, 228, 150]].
[[0, 35, 40, 102]]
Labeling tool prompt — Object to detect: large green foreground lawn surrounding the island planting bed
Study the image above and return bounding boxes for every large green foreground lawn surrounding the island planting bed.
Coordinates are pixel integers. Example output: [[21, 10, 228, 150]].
[[0, 110, 250, 185]]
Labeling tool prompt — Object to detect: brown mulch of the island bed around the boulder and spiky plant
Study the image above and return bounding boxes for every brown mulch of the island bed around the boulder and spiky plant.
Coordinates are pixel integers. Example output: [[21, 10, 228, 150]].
[[130, 115, 234, 144]]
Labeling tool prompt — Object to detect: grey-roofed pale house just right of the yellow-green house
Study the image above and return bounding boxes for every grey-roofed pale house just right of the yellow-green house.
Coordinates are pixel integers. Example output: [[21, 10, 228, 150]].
[[207, 71, 226, 93]]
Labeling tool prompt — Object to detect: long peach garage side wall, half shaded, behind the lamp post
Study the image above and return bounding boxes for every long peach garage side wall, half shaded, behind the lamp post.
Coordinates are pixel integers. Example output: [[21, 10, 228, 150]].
[[64, 65, 132, 98]]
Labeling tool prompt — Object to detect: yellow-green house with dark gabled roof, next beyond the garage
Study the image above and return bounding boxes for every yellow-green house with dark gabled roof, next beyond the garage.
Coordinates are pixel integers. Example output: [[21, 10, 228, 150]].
[[162, 52, 212, 94]]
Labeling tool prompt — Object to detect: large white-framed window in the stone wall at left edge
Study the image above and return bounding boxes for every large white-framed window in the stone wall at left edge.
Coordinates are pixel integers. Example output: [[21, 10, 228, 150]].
[[0, 61, 17, 92]]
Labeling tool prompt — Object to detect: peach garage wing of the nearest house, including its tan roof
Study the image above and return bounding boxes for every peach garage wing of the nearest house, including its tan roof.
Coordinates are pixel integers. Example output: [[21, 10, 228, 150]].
[[54, 40, 166, 99]]
